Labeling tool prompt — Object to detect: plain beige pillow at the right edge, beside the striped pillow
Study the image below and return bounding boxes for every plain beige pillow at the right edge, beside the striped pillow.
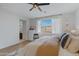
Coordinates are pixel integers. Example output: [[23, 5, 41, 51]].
[[68, 35, 79, 52]]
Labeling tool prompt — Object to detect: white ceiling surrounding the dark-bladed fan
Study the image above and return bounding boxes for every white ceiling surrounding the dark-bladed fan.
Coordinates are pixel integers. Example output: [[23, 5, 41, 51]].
[[0, 3, 79, 18]]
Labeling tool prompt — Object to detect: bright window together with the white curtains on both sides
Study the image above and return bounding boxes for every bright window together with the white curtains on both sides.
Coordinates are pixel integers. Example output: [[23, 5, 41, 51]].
[[38, 18, 61, 34]]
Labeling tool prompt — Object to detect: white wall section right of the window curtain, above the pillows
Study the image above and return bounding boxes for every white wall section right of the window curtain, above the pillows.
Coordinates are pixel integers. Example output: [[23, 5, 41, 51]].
[[61, 12, 76, 31]]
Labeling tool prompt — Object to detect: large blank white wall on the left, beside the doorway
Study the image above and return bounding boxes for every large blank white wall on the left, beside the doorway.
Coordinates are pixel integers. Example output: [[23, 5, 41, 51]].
[[0, 10, 19, 48]]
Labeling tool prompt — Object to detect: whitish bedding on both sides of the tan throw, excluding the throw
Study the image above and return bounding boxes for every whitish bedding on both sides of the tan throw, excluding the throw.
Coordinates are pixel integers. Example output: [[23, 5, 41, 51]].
[[6, 36, 79, 56]]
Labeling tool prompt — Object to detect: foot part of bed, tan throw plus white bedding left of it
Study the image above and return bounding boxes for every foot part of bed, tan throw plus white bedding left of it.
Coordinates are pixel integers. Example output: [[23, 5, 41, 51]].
[[17, 36, 59, 56]]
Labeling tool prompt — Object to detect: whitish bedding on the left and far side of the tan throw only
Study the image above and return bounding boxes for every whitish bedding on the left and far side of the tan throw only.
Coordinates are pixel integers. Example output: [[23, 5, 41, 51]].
[[17, 36, 58, 56]]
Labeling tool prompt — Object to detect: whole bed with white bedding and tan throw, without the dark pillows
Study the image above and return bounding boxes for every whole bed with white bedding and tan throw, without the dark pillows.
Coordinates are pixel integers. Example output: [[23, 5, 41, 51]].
[[6, 32, 79, 56]]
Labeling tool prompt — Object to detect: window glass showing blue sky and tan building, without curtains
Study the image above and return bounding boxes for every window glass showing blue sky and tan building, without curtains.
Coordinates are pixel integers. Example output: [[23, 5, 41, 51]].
[[40, 19, 52, 33]]
